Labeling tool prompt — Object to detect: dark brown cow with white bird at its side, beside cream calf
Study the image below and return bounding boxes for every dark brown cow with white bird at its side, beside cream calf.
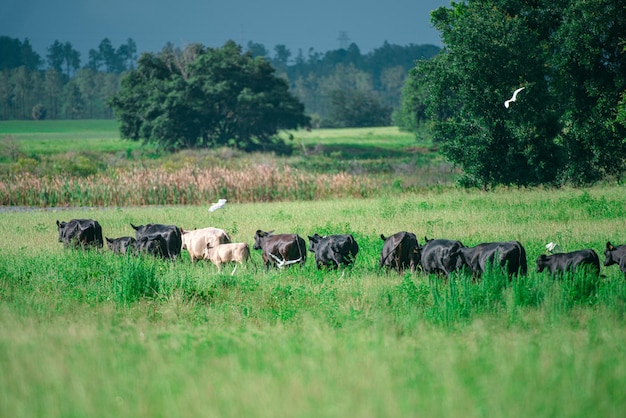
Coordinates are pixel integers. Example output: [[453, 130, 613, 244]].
[[252, 230, 306, 269]]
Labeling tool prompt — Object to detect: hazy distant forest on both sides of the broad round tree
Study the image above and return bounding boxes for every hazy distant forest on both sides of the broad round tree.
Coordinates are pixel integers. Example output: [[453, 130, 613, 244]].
[[0, 36, 440, 127]]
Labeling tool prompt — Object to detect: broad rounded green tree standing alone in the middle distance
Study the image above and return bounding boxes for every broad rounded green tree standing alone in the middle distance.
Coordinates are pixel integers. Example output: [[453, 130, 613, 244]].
[[109, 41, 309, 150]]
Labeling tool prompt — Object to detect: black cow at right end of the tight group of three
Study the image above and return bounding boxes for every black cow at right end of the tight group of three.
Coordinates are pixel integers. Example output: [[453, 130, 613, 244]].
[[461, 241, 528, 277]]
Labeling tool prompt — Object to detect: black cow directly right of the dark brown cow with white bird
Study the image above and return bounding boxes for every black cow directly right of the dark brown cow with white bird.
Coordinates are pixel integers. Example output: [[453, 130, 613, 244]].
[[309, 234, 359, 269]]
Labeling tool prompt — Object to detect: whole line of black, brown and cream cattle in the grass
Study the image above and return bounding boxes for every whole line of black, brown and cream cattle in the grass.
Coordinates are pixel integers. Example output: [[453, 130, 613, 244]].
[[57, 219, 626, 277]]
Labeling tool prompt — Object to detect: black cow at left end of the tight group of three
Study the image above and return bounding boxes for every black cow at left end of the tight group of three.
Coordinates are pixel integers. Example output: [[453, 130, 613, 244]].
[[378, 231, 421, 273]]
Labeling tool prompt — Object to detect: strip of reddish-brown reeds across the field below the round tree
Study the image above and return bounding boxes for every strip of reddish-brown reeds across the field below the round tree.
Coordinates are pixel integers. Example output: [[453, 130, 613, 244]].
[[0, 163, 381, 207]]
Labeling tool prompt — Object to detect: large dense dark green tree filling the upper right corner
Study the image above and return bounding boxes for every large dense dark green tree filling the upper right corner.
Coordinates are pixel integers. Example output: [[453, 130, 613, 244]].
[[404, 0, 626, 187]]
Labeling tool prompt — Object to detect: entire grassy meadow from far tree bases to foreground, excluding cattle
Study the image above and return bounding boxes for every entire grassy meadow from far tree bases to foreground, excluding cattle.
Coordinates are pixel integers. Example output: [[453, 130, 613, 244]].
[[0, 121, 626, 418]]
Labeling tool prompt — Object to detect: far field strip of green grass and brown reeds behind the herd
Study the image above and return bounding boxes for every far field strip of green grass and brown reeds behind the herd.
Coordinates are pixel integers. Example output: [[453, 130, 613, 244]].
[[0, 121, 456, 207]]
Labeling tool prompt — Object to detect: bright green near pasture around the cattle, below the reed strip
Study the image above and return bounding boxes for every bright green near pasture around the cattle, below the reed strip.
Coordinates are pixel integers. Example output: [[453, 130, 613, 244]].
[[0, 186, 626, 417]]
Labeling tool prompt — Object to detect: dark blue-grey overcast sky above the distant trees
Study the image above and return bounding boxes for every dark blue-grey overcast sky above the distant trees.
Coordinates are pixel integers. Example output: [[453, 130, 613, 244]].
[[0, 0, 450, 59]]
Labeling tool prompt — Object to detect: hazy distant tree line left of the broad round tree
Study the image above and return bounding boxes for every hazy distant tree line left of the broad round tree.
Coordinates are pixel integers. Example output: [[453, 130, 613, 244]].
[[0, 36, 137, 120]]
